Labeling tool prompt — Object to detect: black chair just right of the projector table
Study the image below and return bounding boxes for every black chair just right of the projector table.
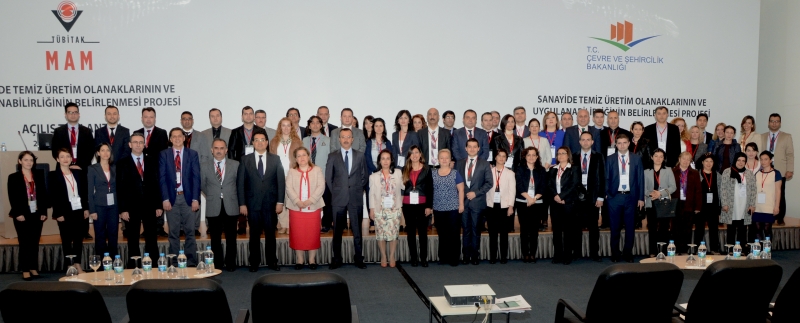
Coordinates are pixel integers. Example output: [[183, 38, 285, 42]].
[[556, 263, 683, 322]]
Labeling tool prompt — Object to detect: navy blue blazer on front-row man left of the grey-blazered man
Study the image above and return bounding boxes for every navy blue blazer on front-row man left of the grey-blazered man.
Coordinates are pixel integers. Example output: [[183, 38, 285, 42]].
[[158, 147, 200, 205]]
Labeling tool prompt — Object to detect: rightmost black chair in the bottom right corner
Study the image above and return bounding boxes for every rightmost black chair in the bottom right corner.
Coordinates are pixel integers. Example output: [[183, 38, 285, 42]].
[[675, 259, 783, 322]]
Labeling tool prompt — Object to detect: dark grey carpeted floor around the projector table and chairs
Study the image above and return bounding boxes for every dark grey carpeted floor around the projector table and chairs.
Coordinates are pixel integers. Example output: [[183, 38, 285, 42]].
[[0, 251, 800, 323]]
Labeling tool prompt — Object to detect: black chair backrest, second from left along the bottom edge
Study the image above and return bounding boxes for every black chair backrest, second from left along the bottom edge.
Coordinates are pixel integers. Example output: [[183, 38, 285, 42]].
[[125, 279, 233, 323]]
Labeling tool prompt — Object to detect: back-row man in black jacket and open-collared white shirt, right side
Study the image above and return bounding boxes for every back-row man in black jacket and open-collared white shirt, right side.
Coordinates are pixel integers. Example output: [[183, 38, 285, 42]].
[[644, 105, 681, 167]]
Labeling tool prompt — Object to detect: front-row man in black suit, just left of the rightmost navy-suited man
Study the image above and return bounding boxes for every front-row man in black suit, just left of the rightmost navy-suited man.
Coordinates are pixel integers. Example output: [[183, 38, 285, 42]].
[[568, 132, 606, 261]]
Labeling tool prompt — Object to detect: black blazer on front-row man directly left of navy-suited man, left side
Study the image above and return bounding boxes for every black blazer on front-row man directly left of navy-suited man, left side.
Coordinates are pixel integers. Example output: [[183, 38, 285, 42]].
[[116, 154, 163, 213]]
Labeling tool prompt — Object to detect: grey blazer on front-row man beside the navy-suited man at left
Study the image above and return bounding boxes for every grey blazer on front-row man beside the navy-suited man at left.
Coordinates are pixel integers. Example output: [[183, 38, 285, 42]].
[[200, 157, 239, 218]]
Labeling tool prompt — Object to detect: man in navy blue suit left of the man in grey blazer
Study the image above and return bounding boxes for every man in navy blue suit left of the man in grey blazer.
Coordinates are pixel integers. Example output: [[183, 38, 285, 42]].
[[158, 127, 200, 266]]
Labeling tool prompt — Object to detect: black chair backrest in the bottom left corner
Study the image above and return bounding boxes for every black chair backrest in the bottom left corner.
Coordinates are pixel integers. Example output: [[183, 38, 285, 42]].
[[0, 282, 111, 323]]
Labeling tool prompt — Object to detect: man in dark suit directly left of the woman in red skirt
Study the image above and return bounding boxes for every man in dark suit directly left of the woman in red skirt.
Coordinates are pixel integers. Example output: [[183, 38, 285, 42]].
[[236, 129, 286, 272]]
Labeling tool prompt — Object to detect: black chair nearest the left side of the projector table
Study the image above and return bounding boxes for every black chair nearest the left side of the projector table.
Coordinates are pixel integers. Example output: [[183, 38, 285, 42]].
[[250, 272, 358, 323]]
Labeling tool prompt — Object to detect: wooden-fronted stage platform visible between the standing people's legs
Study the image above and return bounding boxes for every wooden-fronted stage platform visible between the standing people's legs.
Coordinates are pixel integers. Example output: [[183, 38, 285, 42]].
[[0, 218, 800, 272]]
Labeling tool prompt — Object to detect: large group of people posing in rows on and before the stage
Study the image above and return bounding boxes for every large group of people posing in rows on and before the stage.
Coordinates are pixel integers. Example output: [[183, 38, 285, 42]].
[[8, 103, 794, 279]]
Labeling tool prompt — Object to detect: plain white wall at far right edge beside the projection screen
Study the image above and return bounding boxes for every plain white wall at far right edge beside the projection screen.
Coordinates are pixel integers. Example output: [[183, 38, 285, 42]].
[[760, 0, 800, 218]]
